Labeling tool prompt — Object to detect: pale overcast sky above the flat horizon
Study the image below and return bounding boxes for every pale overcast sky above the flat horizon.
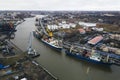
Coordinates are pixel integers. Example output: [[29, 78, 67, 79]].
[[0, 0, 120, 11]]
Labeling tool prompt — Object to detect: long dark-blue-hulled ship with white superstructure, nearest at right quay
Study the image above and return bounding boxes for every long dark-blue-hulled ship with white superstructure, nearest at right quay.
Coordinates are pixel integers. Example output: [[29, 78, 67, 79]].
[[64, 42, 114, 65]]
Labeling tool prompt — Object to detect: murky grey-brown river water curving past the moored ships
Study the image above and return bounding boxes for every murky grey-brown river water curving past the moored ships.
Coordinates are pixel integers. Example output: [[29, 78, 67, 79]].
[[12, 18, 120, 80]]
